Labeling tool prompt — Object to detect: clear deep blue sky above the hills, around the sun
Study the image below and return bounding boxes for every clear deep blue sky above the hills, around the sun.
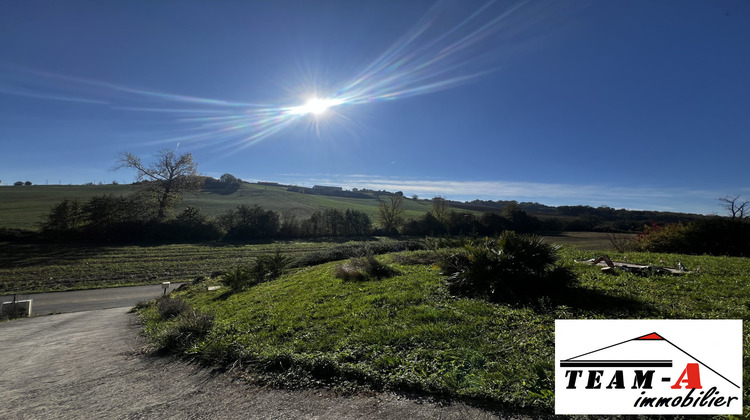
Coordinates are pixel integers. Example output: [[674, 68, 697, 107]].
[[0, 0, 750, 213]]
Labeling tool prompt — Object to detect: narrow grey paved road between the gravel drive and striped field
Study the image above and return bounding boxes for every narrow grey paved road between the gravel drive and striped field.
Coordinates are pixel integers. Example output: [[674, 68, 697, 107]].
[[0, 283, 182, 315]]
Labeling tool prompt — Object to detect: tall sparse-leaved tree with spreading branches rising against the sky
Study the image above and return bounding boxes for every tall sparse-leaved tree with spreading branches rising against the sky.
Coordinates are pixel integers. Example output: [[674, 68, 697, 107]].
[[117, 150, 201, 220]]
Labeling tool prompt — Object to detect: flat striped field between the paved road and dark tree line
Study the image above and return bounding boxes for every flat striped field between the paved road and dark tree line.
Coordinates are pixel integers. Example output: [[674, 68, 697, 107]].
[[0, 242, 335, 295]]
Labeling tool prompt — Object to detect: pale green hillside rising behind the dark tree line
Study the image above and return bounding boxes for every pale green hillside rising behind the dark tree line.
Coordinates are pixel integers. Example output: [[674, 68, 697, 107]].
[[0, 183, 430, 229]]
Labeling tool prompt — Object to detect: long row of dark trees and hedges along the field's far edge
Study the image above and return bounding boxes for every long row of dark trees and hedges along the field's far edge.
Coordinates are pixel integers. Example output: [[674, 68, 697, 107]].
[[36, 188, 560, 242]]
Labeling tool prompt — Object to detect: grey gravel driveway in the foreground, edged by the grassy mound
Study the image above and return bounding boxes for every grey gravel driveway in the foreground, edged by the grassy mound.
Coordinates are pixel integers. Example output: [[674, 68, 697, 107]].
[[0, 307, 528, 419]]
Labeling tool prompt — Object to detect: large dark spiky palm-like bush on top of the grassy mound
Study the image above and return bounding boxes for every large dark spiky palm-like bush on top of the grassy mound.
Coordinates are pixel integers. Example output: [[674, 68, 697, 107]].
[[441, 231, 575, 302]]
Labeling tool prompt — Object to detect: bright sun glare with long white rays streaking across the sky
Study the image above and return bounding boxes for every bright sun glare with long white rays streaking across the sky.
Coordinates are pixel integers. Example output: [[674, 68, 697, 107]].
[[0, 0, 560, 148]]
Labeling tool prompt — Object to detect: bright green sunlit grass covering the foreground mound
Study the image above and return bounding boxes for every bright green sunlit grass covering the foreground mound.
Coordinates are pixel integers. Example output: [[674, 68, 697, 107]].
[[142, 248, 750, 413]]
